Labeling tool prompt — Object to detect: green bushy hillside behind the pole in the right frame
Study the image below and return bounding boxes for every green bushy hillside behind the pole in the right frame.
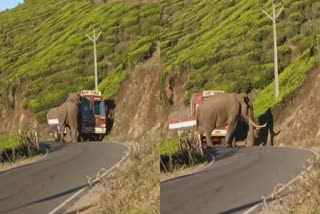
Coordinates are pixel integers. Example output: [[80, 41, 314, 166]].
[[161, 0, 320, 115]]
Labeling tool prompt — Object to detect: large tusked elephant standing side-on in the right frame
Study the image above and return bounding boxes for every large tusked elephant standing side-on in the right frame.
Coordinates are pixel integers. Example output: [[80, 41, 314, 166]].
[[196, 93, 266, 147]]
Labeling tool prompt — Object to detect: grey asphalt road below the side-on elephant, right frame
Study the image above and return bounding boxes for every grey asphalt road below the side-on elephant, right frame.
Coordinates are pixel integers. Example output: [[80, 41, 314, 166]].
[[160, 147, 314, 214]]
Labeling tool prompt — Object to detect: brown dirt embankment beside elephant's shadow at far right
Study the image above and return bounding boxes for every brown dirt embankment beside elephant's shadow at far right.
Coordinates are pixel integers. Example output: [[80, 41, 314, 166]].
[[275, 67, 320, 147]]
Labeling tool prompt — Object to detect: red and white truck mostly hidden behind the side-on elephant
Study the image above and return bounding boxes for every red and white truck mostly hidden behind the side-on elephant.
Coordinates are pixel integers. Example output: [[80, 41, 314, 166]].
[[168, 90, 228, 147]]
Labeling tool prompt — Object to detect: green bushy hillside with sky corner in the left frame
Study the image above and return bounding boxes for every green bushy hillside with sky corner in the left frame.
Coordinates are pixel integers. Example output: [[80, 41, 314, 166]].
[[0, 0, 160, 121]]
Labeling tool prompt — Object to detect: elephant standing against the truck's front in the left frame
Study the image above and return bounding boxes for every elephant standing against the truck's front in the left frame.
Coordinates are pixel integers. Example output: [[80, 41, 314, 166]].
[[55, 93, 80, 143]]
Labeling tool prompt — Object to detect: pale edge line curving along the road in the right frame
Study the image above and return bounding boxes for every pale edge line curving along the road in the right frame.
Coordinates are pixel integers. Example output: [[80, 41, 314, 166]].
[[242, 146, 320, 214]]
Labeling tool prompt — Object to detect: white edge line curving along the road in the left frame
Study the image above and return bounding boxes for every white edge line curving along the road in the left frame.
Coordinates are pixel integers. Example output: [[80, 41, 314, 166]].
[[48, 143, 131, 214]]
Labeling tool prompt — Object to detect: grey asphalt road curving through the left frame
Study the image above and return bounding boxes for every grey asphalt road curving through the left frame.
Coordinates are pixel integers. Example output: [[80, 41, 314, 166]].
[[0, 142, 127, 214]]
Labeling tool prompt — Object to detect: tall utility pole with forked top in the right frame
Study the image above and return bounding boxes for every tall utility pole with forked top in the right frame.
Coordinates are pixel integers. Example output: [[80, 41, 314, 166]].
[[262, 1, 283, 99]]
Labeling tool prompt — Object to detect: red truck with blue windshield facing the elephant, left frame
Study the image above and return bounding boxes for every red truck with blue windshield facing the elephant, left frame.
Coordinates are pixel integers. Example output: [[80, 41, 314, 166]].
[[47, 90, 107, 141]]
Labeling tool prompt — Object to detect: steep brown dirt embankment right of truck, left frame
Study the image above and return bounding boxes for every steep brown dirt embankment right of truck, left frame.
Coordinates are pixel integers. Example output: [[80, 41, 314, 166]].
[[109, 43, 162, 140]]
